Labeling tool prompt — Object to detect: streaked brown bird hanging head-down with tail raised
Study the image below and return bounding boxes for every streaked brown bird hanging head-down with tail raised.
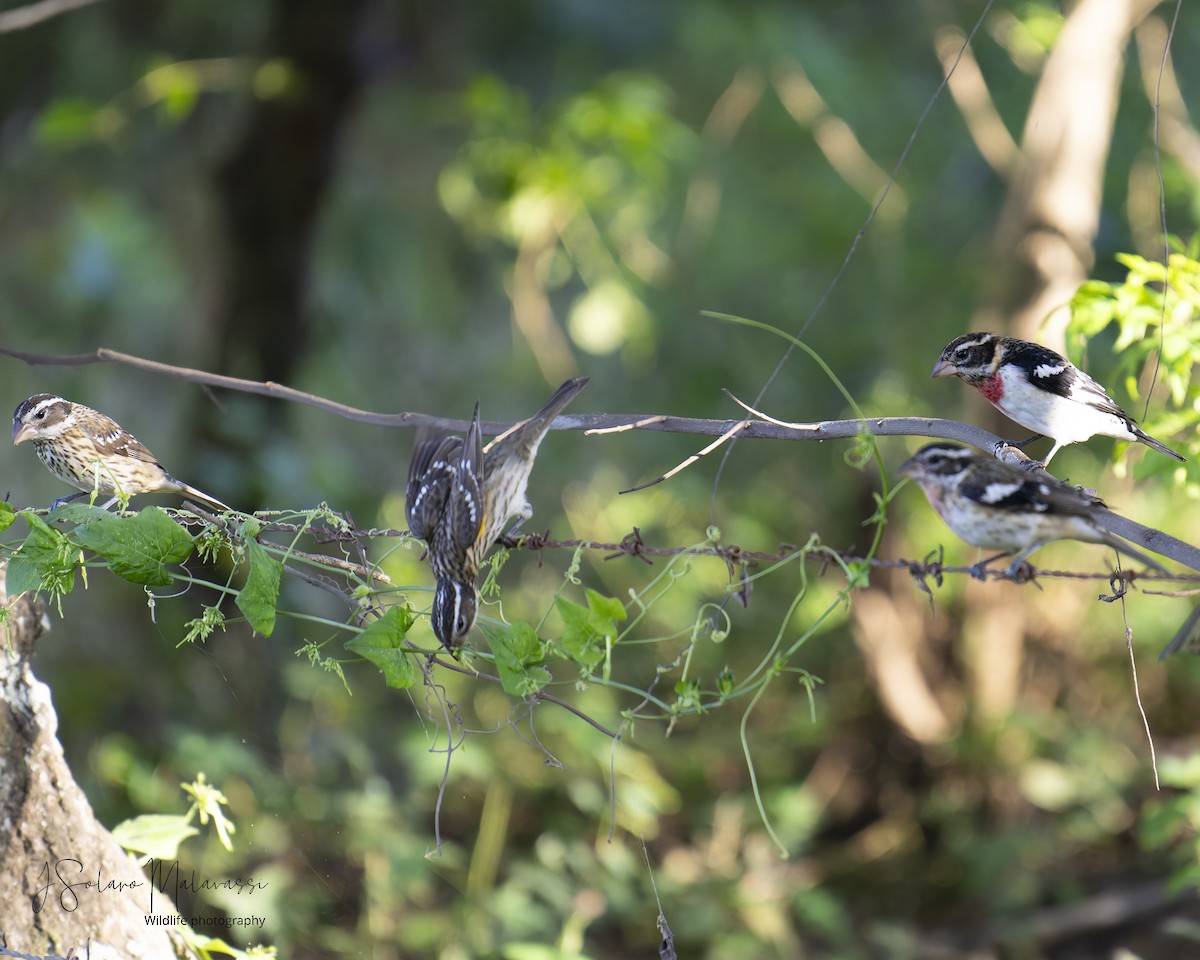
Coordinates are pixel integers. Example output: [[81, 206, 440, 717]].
[[404, 377, 588, 649]]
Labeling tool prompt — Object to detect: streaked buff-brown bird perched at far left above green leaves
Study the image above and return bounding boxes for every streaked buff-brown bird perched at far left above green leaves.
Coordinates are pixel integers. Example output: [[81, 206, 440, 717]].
[[12, 394, 230, 510]]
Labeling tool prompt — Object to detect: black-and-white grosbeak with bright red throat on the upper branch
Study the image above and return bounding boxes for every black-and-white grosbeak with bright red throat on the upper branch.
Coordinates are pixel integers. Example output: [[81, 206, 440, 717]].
[[931, 334, 1187, 466]]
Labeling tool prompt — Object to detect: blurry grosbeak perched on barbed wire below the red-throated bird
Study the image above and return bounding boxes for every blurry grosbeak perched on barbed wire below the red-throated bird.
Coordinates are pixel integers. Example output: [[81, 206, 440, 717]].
[[900, 443, 1163, 575]]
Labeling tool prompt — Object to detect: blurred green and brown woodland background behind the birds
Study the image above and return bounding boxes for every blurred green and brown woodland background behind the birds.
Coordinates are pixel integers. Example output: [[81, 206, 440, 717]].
[[0, 0, 1200, 960]]
